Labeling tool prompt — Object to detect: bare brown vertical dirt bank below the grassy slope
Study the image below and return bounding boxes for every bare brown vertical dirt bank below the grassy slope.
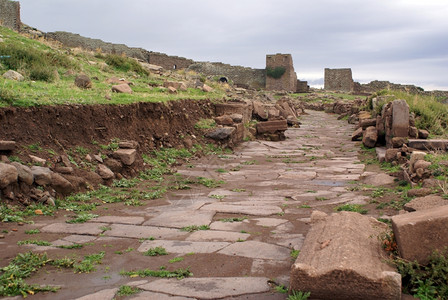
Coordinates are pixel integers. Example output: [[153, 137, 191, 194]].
[[0, 100, 214, 152]]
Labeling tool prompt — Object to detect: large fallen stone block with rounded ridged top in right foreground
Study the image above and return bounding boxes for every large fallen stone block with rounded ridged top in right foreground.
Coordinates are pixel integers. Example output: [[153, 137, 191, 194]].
[[290, 212, 401, 300]]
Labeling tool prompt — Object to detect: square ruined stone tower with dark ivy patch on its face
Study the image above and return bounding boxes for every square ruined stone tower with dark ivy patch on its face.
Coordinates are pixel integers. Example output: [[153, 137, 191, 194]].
[[266, 53, 297, 92]]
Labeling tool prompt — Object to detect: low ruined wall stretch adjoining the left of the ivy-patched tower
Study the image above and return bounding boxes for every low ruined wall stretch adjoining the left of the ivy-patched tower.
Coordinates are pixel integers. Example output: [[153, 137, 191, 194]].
[[188, 62, 266, 89]]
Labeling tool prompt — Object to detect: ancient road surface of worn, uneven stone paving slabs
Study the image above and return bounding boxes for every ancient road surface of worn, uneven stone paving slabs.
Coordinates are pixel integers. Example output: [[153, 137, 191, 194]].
[[9, 111, 378, 299]]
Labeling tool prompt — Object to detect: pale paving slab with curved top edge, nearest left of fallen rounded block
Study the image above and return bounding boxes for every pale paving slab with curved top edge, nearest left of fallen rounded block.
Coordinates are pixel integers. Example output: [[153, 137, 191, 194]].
[[218, 241, 291, 260]]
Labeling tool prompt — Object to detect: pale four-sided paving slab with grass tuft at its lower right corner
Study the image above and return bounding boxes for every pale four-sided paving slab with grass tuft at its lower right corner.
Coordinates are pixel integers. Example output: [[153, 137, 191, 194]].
[[144, 210, 215, 228]]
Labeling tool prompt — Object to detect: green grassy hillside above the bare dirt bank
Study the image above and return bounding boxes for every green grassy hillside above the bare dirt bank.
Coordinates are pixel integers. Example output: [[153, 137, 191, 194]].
[[0, 27, 225, 106]]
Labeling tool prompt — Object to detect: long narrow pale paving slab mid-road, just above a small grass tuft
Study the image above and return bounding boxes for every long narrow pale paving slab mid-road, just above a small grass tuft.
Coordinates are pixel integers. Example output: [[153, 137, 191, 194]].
[[201, 202, 282, 216]]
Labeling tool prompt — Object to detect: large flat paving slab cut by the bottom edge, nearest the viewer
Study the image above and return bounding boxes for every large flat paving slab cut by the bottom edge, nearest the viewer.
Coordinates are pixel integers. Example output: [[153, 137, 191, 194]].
[[139, 277, 270, 299]]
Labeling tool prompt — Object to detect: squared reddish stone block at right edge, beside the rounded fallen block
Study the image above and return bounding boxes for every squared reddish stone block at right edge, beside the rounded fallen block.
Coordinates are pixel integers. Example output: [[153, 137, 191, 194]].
[[392, 205, 448, 265]]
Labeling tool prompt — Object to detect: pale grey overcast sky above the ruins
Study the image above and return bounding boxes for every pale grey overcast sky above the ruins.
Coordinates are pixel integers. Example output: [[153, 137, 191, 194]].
[[20, 0, 448, 90]]
